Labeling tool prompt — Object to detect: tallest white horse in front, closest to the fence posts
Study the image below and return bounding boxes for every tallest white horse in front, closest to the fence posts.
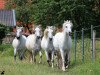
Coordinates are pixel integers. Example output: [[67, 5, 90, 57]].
[[53, 20, 72, 71]]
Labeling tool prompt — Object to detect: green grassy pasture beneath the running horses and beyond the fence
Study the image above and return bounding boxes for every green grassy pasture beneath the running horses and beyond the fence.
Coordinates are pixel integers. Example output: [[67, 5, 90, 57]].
[[0, 39, 100, 75]]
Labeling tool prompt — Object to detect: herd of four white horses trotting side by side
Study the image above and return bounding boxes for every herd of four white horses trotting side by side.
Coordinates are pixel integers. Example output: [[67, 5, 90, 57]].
[[12, 20, 73, 71]]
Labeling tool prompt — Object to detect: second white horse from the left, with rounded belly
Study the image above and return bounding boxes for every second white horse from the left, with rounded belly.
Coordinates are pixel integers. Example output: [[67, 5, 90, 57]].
[[26, 25, 42, 63]]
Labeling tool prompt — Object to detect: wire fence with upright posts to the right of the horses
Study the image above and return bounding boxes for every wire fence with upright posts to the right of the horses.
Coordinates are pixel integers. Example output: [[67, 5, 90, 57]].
[[73, 25, 100, 63]]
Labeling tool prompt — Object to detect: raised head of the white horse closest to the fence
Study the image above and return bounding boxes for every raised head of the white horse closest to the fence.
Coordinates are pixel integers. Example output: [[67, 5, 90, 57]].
[[63, 20, 73, 36]]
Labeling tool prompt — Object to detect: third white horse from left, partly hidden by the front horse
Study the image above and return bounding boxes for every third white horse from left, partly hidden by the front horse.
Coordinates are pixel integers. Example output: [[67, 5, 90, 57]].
[[41, 26, 54, 68]]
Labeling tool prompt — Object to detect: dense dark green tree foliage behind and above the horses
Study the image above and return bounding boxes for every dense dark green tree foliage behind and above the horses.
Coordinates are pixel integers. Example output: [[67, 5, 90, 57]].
[[7, 0, 100, 30]]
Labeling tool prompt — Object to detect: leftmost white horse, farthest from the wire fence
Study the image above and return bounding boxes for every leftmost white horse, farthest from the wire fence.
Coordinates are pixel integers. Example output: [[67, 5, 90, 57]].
[[12, 27, 26, 60]]
